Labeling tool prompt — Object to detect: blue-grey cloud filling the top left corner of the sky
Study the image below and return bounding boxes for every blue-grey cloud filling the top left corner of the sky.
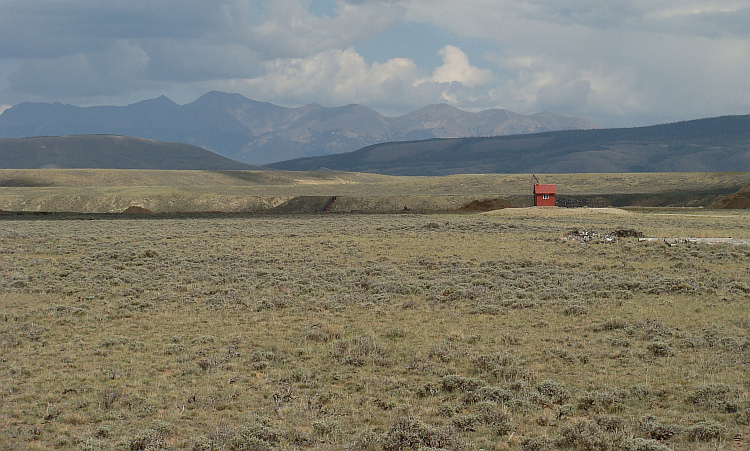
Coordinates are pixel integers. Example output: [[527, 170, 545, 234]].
[[0, 0, 253, 58]]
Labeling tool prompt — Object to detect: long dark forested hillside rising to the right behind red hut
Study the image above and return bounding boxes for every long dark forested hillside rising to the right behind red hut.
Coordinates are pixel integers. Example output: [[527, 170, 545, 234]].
[[268, 115, 750, 175]]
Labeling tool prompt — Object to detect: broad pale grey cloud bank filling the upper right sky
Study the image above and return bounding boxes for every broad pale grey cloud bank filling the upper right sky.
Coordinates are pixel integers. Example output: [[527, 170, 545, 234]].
[[405, 0, 750, 125]]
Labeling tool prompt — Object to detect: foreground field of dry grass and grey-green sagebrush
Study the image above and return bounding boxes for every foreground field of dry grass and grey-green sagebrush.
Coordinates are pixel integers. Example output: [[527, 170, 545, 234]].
[[0, 209, 750, 451]]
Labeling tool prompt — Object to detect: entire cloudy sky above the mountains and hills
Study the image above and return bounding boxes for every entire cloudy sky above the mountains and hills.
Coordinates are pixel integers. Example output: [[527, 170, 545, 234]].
[[0, 0, 750, 127]]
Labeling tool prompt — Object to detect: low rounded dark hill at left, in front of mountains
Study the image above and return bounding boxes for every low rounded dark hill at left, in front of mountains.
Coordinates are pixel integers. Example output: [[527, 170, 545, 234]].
[[0, 135, 253, 170]]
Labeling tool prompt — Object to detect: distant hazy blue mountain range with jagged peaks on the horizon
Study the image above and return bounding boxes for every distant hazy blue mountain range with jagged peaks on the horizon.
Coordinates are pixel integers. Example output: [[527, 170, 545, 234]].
[[0, 91, 598, 164]]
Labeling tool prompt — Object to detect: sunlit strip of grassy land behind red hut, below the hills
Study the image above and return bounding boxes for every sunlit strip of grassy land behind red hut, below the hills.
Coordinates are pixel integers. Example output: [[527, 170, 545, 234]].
[[0, 169, 750, 213]]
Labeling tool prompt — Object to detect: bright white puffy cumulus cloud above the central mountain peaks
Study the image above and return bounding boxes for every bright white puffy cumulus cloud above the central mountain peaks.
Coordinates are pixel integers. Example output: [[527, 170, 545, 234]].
[[229, 46, 492, 113]]
